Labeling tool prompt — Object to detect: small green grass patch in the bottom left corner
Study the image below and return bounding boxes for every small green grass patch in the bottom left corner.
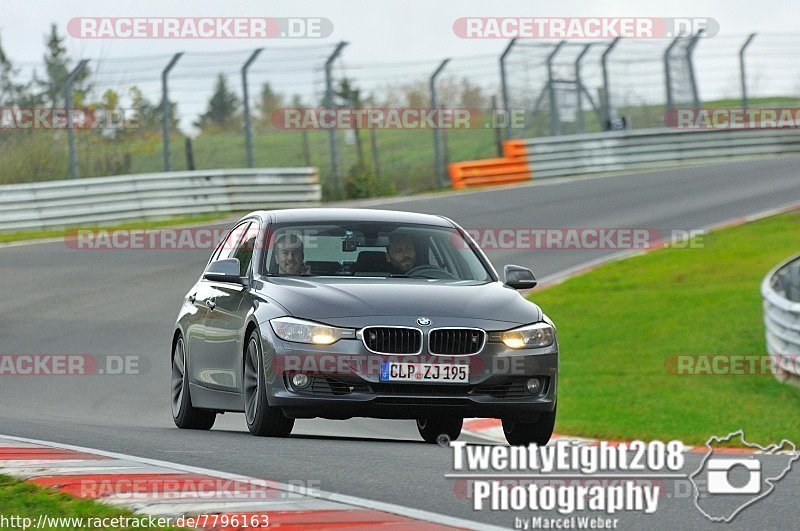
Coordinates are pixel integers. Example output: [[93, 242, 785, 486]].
[[0, 475, 184, 530]]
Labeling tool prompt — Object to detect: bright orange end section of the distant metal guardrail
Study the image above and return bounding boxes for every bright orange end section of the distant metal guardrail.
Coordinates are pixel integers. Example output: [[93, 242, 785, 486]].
[[448, 140, 533, 188]]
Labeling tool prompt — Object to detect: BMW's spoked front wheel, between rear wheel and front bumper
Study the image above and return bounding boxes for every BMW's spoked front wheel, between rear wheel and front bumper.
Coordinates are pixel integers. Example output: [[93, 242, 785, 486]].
[[243, 330, 294, 437]]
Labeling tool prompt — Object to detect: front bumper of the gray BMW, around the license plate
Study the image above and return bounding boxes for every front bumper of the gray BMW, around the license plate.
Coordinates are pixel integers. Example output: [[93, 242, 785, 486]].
[[264, 336, 558, 422]]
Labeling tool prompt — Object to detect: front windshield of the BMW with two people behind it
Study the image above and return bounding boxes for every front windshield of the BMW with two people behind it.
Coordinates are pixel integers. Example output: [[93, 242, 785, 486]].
[[264, 222, 492, 282]]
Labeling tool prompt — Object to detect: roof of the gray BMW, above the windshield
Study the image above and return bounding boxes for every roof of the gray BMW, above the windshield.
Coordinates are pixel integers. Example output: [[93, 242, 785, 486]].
[[245, 208, 453, 227]]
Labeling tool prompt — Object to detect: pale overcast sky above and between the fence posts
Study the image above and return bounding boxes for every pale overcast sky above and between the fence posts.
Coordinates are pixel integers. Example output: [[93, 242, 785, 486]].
[[0, 0, 800, 130]]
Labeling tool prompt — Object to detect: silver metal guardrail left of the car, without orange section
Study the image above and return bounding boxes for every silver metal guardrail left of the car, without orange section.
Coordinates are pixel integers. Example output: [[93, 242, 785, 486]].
[[0, 168, 322, 231]]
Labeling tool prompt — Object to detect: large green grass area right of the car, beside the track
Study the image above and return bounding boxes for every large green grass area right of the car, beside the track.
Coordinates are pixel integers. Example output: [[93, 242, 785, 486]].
[[530, 213, 800, 444]]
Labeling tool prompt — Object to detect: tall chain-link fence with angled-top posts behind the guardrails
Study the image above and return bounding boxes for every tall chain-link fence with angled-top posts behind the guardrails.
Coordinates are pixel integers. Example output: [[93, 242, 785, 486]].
[[0, 35, 800, 197]]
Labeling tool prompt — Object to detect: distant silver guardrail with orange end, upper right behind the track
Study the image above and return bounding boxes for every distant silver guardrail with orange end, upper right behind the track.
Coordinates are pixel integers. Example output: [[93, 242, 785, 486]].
[[450, 128, 800, 187]]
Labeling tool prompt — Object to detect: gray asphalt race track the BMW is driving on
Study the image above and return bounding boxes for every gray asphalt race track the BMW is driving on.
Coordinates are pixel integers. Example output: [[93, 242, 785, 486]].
[[0, 157, 800, 529]]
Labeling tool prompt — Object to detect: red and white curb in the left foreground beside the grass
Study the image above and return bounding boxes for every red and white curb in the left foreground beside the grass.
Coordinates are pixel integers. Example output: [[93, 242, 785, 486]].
[[0, 435, 499, 531]]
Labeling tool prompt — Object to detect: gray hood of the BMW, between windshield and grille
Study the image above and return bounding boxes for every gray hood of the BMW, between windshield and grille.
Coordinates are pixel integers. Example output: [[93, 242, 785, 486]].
[[260, 277, 542, 324]]
